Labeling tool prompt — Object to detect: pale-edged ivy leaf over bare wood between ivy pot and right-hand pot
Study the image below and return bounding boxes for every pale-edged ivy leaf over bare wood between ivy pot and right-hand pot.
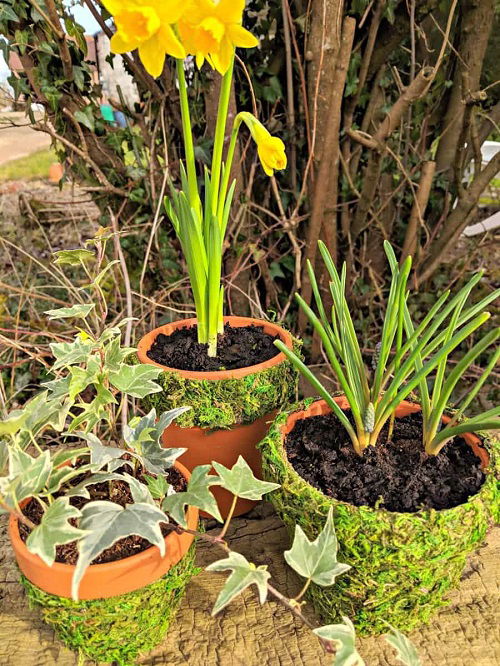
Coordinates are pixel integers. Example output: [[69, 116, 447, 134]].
[[207, 551, 271, 615]]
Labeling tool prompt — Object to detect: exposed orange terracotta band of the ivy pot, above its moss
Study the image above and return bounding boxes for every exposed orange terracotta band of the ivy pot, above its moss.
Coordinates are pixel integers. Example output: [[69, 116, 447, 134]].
[[9, 462, 198, 600]]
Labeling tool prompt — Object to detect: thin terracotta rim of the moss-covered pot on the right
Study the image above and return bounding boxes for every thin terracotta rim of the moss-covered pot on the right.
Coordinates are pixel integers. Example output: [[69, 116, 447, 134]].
[[278, 394, 490, 516]]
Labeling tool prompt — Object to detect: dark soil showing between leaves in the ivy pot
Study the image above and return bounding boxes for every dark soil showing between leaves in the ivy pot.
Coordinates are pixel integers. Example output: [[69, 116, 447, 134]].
[[19, 466, 187, 564]]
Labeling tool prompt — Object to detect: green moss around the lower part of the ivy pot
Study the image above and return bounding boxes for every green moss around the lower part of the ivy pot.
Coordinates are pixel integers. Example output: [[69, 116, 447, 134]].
[[21, 545, 199, 666]]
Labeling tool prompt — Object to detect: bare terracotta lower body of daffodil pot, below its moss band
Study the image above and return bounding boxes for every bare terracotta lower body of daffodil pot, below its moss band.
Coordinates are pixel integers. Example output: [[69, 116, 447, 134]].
[[162, 412, 276, 518]]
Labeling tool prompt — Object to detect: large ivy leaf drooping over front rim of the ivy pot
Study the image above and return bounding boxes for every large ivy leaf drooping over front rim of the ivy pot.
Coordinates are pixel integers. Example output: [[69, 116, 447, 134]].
[[71, 501, 168, 600]]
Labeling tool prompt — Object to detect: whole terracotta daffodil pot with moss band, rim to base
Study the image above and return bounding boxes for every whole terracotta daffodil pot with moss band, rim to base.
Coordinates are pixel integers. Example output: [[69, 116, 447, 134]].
[[137, 316, 298, 517]]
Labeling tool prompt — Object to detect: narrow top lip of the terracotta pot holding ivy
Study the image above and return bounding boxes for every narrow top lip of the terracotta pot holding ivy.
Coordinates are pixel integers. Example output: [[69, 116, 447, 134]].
[[9, 461, 198, 576]]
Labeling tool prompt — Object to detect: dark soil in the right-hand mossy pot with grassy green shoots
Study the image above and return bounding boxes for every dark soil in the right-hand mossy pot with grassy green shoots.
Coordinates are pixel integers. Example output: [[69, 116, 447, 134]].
[[285, 414, 485, 513]]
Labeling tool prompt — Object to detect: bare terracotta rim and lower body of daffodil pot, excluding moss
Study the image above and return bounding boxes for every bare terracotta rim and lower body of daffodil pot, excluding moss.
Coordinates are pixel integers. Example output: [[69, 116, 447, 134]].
[[137, 316, 293, 518]]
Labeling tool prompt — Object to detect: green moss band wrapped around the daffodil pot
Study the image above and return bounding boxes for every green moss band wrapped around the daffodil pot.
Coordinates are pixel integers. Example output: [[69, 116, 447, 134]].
[[143, 340, 301, 429]]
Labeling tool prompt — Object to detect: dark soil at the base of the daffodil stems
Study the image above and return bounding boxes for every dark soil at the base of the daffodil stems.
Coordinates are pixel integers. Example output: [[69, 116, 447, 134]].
[[147, 324, 279, 372]]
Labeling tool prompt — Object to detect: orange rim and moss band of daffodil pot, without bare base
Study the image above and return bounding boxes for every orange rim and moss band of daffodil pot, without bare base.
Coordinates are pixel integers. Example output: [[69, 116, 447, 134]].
[[137, 317, 299, 429]]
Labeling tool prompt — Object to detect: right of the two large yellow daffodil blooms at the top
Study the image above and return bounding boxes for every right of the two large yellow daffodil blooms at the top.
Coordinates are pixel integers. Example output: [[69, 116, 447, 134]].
[[178, 0, 259, 74]]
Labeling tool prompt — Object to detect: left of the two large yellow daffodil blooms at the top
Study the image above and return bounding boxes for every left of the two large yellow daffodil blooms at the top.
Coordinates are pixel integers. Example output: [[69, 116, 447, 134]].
[[102, 0, 186, 78]]
